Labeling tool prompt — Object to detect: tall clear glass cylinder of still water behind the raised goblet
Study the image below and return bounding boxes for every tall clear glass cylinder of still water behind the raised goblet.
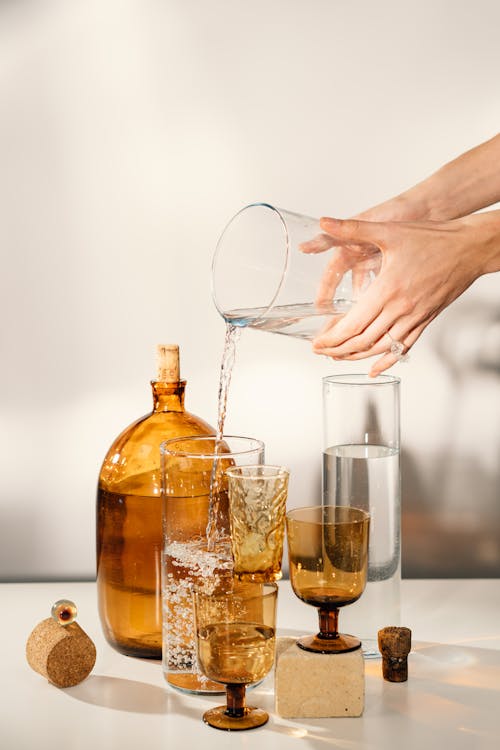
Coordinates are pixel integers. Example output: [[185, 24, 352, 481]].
[[323, 375, 401, 657]]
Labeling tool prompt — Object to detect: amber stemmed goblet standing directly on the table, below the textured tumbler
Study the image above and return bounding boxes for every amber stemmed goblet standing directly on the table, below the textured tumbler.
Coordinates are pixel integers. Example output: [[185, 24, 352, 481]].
[[193, 581, 278, 731]]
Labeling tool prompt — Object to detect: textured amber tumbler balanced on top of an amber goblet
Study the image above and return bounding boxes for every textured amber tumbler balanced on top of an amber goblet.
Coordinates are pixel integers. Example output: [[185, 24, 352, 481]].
[[226, 464, 289, 582]]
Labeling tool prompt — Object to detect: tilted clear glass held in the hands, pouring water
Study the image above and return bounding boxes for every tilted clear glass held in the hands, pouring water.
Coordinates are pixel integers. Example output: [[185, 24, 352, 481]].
[[212, 203, 380, 339]]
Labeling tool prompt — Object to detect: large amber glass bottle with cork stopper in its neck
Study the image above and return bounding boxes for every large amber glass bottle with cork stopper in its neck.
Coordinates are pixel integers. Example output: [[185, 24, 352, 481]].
[[97, 345, 215, 659]]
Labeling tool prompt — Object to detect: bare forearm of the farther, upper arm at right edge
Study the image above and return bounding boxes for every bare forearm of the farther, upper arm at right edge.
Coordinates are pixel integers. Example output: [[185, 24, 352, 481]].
[[395, 134, 500, 221]]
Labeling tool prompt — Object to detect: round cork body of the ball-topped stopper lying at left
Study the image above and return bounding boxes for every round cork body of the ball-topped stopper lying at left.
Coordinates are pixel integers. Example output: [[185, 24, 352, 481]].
[[26, 617, 96, 687]]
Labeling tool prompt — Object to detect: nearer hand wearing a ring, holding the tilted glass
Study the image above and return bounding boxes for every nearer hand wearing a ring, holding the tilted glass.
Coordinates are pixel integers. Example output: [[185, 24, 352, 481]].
[[313, 212, 492, 376]]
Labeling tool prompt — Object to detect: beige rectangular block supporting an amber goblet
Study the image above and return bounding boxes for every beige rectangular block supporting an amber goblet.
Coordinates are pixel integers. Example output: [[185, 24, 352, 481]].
[[275, 638, 365, 719]]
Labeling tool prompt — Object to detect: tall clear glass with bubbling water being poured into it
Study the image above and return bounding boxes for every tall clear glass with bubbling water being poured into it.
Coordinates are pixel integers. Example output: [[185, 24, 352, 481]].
[[160, 435, 264, 693]]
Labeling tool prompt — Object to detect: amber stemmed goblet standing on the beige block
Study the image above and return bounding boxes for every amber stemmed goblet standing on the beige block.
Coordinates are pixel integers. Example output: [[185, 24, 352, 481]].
[[286, 505, 370, 654]]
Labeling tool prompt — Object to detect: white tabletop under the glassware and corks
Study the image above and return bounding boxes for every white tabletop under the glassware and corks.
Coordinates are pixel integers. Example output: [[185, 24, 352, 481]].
[[0, 580, 500, 750]]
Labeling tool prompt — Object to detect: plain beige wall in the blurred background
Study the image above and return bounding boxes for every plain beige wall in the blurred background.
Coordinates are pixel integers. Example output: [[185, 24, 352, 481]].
[[0, 0, 500, 580]]
